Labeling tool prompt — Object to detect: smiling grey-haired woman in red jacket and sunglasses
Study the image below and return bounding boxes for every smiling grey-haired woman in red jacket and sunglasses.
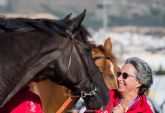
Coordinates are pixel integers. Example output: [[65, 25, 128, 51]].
[[96, 57, 153, 113]]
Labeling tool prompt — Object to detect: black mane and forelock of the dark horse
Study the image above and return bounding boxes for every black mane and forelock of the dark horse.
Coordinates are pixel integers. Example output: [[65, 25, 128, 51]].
[[0, 17, 91, 43]]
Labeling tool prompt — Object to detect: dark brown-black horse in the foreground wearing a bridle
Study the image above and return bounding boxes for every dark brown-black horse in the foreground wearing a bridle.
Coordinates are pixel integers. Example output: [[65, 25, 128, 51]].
[[0, 11, 108, 109]]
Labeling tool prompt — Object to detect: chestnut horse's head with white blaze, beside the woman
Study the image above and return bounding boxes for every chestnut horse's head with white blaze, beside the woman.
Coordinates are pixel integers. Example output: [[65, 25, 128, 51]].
[[92, 38, 118, 89]]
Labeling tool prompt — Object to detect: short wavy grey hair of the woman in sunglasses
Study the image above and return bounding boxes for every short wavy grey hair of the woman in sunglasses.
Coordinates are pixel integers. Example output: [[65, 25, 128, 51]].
[[125, 57, 153, 95]]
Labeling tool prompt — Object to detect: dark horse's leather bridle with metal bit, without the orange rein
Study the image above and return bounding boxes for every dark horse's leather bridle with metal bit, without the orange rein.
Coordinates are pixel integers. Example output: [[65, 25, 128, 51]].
[[66, 30, 98, 98]]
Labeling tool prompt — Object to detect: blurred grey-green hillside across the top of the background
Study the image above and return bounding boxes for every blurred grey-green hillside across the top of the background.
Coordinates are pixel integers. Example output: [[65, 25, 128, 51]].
[[0, 0, 165, 29]]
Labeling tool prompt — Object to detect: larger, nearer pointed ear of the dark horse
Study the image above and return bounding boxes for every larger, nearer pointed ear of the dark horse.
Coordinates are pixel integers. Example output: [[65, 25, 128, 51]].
[[69, 9, 86, 31]]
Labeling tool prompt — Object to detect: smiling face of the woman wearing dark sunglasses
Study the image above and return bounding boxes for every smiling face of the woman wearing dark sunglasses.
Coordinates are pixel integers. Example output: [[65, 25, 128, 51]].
[[117, 64, 141, 93]]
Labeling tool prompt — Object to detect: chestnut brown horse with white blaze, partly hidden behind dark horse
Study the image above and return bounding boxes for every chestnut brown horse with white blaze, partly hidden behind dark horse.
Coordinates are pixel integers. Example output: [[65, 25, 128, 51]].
[[30, 38, 118, 113]]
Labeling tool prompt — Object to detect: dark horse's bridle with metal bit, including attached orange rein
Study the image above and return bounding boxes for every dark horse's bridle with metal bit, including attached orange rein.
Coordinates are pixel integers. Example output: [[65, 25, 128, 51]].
[[56, 30, 99, 113]]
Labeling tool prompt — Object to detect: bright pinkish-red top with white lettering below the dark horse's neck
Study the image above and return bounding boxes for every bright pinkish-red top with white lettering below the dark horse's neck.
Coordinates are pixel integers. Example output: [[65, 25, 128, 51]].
[[0, 89, 44, 113]]
